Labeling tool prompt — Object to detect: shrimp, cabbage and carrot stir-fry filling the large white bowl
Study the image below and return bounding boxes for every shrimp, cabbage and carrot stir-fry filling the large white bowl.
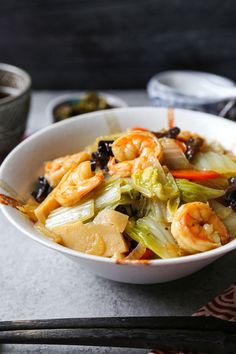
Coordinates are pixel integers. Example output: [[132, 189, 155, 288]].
[[11, 127, 236, 260]]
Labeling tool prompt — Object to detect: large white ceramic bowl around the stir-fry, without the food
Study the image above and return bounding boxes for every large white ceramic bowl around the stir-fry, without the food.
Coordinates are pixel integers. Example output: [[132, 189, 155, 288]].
[[0, 107, 236, 284]]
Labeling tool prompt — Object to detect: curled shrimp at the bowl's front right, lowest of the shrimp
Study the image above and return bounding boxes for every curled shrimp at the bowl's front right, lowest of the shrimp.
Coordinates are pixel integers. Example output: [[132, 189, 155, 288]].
[[171, 202, 229, 254]]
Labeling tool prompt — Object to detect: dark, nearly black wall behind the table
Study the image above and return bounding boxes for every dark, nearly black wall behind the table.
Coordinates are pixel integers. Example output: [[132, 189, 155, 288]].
[[0, 0, 236, 89]]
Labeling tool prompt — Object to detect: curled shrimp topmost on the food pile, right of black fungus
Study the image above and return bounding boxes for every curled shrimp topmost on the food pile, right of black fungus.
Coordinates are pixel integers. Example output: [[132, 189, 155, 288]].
[[107, 131, 162, 177]]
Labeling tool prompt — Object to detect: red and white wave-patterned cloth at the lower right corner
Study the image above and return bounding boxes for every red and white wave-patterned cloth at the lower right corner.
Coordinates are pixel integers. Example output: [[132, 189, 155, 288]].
[[149, 283, 236, 354]]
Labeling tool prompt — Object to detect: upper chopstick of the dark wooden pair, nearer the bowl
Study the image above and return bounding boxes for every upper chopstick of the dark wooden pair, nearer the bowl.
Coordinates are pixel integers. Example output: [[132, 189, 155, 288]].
[[0, 316, 236, 334]]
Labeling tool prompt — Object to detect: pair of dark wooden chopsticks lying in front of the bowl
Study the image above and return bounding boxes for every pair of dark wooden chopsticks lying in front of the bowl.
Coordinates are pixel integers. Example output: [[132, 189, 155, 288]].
[[0, 317, 236, 354]]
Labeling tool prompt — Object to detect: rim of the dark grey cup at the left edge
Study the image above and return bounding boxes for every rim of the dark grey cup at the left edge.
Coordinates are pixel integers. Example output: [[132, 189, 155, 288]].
[[0, 63, 32, 107]]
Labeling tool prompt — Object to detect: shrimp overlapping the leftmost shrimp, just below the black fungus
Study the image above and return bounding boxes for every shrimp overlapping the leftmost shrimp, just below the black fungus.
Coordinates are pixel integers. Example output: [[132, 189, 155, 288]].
[[55, 161, 104, 206]]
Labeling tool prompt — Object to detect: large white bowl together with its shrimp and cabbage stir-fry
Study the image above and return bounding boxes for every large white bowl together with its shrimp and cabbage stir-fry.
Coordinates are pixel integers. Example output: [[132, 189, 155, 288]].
[[0, 107, 236, 284]]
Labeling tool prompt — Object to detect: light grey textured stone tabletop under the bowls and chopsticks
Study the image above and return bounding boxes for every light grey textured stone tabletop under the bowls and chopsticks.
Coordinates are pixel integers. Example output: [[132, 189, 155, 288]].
[[0, 91, 236, 354]]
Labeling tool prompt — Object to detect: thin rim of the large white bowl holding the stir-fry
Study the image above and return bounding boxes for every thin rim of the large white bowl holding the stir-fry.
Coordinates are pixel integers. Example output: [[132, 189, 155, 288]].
[[0, 106, 236, 266]]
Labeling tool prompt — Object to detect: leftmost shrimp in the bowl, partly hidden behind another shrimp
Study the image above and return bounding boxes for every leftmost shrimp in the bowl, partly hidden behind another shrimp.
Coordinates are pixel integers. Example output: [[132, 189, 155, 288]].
[[44, 151, 90, 187]]
